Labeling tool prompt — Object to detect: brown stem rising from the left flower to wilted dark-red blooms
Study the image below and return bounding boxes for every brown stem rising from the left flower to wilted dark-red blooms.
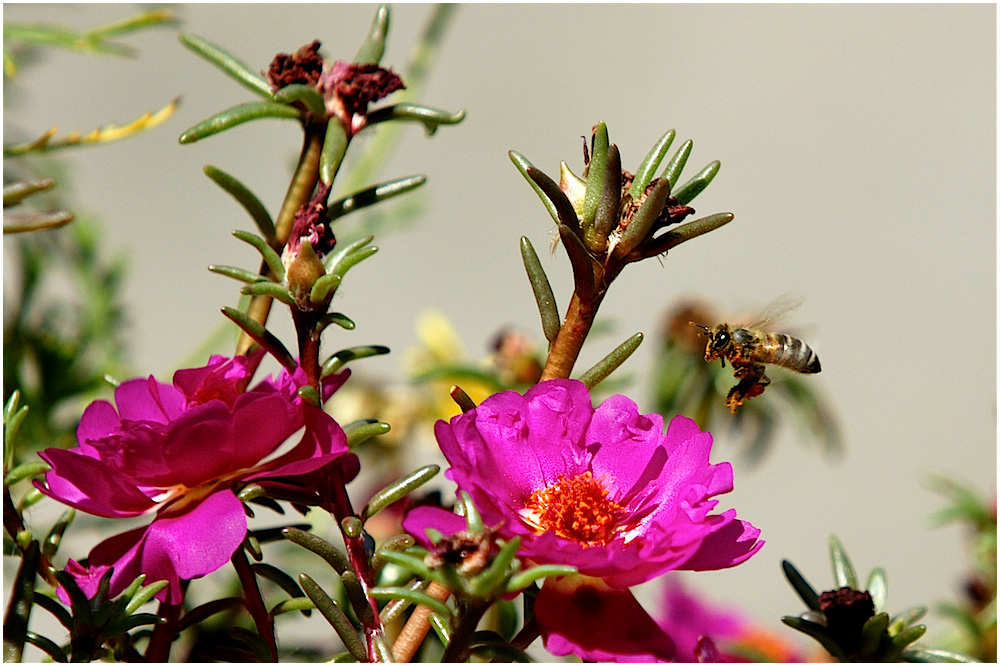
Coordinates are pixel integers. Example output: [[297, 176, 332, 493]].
[[236, 118, 326, 358]]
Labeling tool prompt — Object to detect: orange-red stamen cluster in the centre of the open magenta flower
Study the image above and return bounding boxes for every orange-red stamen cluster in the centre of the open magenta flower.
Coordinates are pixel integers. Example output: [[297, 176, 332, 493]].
[[522, 471, 625, 548]]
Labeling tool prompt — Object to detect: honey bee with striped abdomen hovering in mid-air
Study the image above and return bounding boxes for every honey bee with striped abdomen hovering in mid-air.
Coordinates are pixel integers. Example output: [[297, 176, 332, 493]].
[[690, 294, 820, 414]]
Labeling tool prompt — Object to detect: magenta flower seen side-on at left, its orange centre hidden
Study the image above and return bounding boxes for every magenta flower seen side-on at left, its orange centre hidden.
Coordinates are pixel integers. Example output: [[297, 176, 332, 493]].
[[35, 356, 348, 603]]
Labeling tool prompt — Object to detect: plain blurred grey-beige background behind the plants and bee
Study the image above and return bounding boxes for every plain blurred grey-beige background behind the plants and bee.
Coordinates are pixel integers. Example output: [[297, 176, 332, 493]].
[[4, 5, 997, 648]]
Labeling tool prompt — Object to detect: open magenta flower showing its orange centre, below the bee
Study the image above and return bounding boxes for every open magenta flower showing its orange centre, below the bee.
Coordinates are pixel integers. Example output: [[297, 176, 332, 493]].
[[403, 379, 763, 661]]
